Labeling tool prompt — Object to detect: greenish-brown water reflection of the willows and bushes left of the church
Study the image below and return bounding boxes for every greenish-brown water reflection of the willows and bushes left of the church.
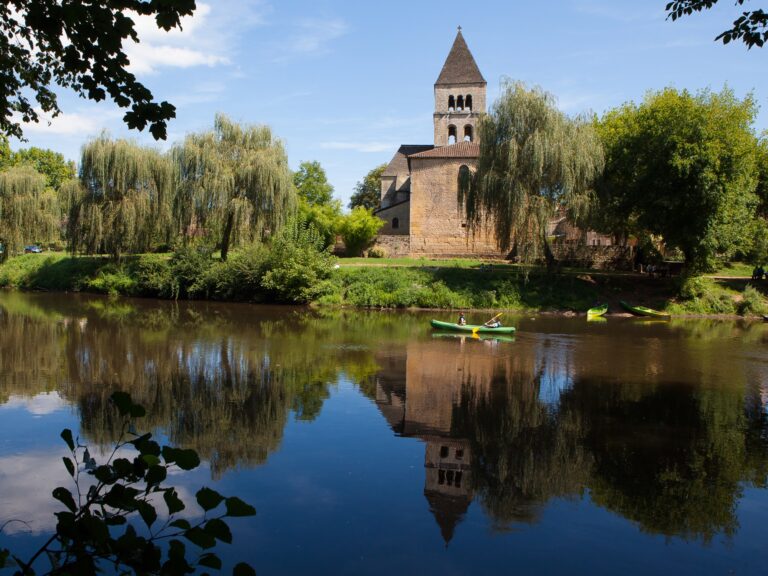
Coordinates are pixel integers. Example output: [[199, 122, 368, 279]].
[[0, 295, 420, 475]]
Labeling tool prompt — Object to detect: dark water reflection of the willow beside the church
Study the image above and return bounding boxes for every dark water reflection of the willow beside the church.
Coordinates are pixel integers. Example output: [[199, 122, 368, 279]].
[[453, 371, 591, 527]]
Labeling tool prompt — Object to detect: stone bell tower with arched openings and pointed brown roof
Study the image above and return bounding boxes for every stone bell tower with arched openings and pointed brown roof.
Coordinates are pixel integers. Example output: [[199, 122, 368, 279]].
[[434, 26, 487, 146]]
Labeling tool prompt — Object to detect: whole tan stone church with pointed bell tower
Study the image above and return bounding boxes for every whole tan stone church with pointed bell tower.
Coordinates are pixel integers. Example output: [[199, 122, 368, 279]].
[[374, 28, 503, 257]]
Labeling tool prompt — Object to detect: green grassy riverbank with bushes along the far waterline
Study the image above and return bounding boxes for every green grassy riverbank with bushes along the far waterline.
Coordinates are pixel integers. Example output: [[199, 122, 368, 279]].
[[0, 252, 768, 316]]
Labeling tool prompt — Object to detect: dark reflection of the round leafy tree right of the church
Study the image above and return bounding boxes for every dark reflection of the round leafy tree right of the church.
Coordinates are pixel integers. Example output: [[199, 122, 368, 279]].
[[568, 382, 767, 541]]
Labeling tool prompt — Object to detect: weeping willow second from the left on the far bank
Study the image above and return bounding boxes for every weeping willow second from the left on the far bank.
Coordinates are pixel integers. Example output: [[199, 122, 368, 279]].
[[67, 134, 173, 259]]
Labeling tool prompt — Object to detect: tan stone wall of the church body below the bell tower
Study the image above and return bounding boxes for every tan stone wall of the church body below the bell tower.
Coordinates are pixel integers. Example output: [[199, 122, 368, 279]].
[[410, 158, 502, 258]]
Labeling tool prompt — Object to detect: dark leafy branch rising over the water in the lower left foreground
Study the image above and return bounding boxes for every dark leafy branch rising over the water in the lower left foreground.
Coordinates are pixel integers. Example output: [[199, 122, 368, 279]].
[[0, 392, 256, 576]]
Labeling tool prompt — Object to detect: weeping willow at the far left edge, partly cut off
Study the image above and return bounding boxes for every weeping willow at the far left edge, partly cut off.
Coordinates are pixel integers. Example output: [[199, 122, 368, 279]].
[[0, 166, 61, 261]]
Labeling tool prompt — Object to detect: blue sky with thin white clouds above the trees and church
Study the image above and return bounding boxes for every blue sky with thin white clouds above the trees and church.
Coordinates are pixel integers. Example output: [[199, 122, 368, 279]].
[[12, 0, 768, 204]]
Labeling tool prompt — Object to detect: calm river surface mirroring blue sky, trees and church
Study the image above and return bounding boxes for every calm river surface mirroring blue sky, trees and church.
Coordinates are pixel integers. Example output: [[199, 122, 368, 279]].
[[0, 293, 768, 576]]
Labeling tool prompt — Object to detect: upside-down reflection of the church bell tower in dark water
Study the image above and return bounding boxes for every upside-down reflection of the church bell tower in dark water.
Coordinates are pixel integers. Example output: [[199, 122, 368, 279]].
[[424, 437, 472, 545]]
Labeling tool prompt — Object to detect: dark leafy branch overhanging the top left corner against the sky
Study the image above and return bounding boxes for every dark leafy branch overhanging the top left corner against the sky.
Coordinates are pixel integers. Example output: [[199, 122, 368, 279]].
[[0, 0, 195, 139]]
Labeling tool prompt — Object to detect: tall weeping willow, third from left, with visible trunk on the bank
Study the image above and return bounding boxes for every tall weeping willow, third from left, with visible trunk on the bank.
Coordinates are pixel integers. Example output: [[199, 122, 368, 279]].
[[173, 114, 297, 260]]
